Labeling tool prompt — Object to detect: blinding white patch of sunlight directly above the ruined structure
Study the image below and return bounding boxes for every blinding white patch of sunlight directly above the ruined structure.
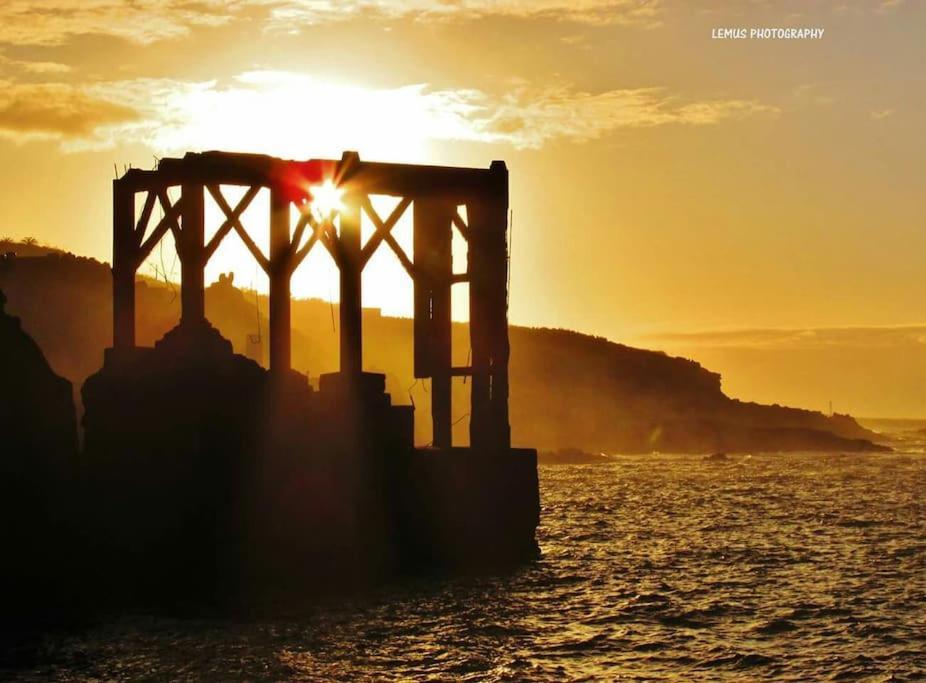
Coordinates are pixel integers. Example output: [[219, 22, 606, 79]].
[[144, 70, 480, 162]]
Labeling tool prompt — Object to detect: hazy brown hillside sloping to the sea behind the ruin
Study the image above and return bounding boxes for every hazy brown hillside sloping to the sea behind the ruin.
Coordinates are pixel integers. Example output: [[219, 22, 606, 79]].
[[0, 242, 877, 452]]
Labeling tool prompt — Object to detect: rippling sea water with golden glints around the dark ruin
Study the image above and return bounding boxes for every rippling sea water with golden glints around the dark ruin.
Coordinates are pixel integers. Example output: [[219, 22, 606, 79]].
[[9, 454, 926, 681]]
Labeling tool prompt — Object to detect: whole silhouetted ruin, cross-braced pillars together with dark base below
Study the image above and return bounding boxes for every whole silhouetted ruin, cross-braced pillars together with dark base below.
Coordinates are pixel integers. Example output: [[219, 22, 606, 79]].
[[83, 152, 539, 590]]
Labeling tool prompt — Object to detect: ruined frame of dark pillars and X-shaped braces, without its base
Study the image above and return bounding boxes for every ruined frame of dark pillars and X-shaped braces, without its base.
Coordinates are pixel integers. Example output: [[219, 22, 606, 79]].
[[113, 152, 511, 450]]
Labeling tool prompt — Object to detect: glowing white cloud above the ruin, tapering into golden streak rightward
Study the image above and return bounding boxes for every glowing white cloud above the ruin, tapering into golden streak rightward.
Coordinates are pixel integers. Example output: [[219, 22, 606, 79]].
[[125, 71, 775, 156]]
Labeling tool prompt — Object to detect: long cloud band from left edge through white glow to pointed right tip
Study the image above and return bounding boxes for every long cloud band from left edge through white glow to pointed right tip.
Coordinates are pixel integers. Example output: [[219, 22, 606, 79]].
[[0, 71, 777, 160]]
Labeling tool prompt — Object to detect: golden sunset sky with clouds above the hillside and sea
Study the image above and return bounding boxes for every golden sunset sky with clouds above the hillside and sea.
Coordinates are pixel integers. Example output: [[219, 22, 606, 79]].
[[0, 0, 926, 416]]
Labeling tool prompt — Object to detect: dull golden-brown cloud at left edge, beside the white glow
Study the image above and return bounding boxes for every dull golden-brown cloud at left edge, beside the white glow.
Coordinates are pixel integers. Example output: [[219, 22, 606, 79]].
[[0, 81, 139, 142]]
